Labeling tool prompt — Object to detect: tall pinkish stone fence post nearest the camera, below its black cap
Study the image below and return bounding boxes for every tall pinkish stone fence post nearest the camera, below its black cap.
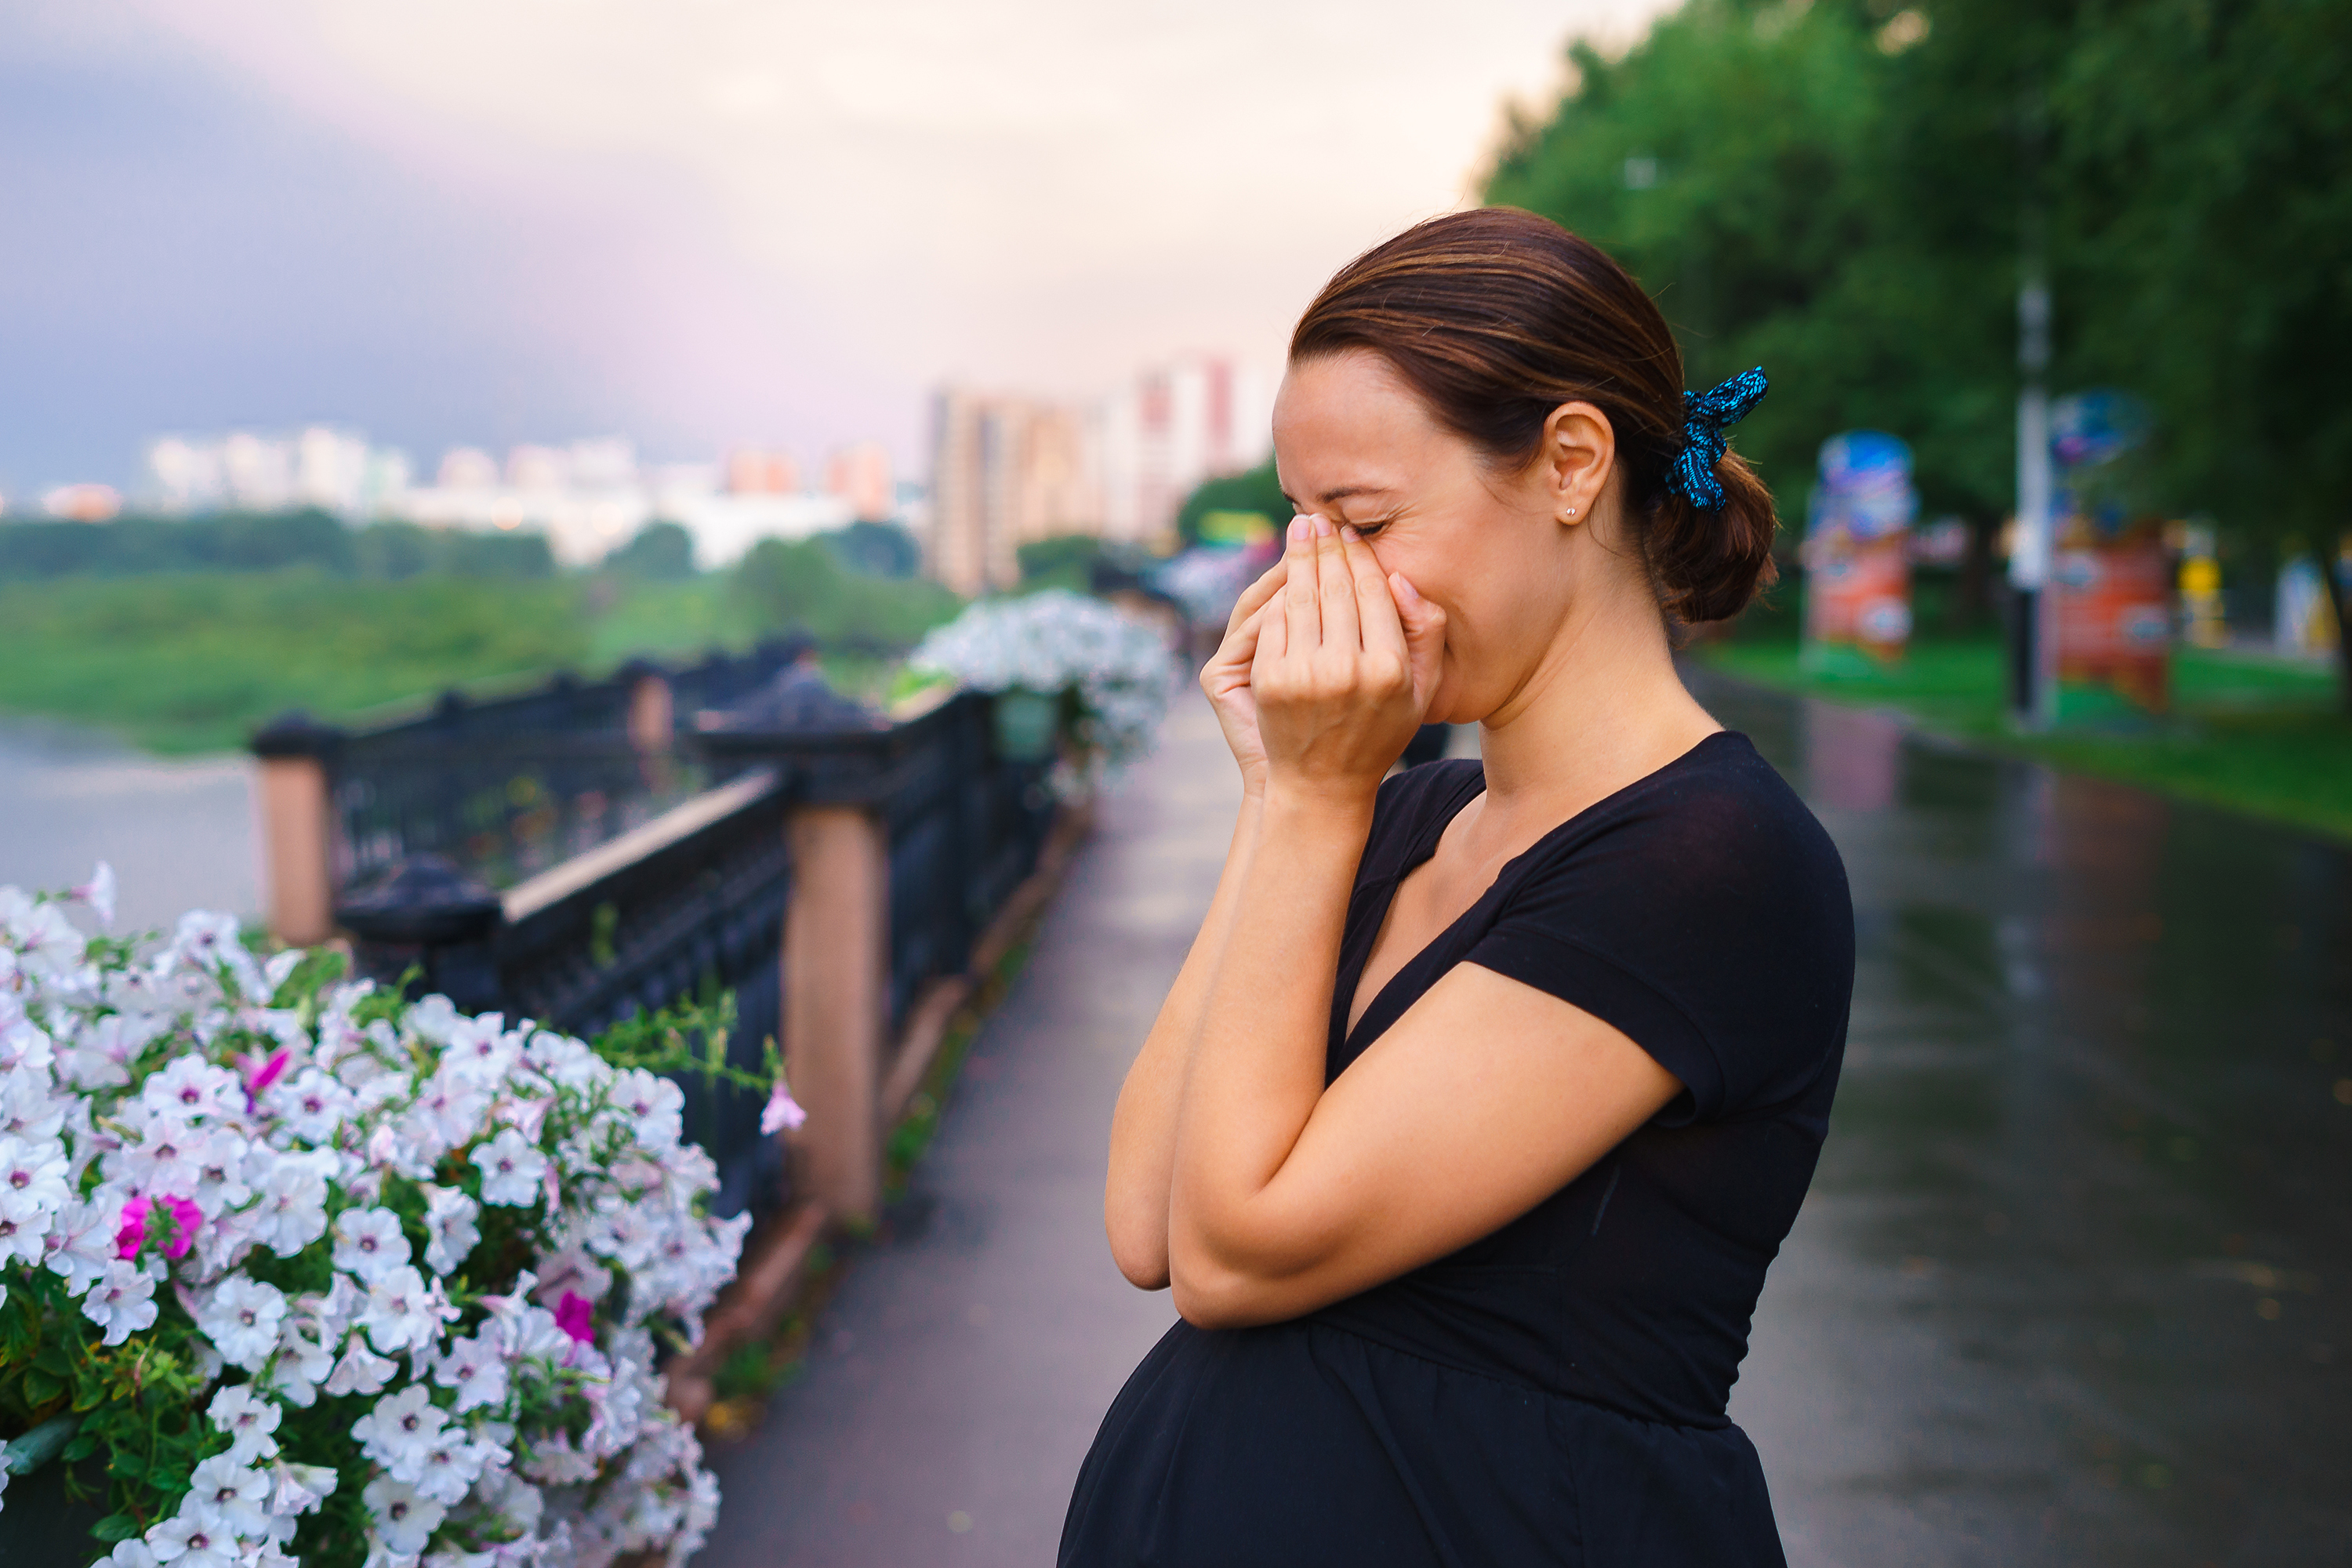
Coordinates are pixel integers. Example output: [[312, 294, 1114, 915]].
[[783, 806, 889, 1222]]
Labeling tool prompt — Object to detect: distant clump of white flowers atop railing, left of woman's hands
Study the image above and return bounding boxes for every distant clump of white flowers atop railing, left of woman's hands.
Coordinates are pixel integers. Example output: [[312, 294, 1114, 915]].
[[910, 588, 1176, 792]]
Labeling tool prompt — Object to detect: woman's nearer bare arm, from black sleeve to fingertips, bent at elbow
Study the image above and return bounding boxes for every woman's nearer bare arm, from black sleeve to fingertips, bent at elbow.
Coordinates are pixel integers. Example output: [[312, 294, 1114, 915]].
[[1162, 514, 1679, 1326]]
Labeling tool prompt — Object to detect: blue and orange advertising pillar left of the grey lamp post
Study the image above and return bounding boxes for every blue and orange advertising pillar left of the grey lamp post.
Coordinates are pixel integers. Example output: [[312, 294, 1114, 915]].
[[1802, 430, 1919, 675]]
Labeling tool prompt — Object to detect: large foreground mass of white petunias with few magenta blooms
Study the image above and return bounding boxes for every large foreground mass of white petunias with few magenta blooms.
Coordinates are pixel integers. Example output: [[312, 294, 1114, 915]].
[[0, 867, 790, 1568]]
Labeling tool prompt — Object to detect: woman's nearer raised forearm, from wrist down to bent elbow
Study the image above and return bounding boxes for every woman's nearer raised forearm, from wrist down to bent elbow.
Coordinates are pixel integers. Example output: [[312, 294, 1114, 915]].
[[1169, 789, 1371, 1309]]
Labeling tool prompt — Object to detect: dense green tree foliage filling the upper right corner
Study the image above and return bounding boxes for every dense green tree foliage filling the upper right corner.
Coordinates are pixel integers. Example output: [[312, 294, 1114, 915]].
[[1486, 0, 2352, 689]]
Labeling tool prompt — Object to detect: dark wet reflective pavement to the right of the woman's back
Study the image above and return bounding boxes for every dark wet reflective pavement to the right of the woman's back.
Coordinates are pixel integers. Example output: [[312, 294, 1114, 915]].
[[1693, 677, 2352, 1568]]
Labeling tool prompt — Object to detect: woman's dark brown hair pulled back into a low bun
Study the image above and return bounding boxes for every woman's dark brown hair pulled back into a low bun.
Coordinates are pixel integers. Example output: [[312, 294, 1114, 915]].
[[1291, 207, 1778, 621]]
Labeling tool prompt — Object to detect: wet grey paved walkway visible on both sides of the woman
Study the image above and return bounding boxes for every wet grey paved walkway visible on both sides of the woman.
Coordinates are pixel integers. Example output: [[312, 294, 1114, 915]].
[[696, 677, 2352, 1568]]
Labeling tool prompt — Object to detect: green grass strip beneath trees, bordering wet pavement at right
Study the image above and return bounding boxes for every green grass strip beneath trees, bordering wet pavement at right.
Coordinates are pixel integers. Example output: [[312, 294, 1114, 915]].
[[1693, 635, 2352, 841]]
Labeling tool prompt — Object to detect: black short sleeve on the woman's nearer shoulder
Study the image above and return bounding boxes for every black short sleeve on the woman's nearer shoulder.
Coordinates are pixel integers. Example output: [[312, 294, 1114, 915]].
[[1463, 736, 1853, 1123]]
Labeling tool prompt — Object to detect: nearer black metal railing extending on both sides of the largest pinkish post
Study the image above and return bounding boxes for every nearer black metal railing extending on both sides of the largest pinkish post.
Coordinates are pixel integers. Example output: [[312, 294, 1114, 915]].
[[336, 694, 1054, 1213]]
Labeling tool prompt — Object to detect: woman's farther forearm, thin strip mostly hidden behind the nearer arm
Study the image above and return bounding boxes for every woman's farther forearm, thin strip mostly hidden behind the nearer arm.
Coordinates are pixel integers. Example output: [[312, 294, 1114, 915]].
[[1103, 792, 1263, 1290]]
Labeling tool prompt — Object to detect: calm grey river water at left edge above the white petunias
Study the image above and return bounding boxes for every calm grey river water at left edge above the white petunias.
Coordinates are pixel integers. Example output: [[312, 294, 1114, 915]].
[[0, 720, 261, 931]]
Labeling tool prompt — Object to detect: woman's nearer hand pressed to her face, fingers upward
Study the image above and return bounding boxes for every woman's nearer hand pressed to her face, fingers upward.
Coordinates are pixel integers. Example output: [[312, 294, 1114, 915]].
[[1228, 517, 1446, 799]]
